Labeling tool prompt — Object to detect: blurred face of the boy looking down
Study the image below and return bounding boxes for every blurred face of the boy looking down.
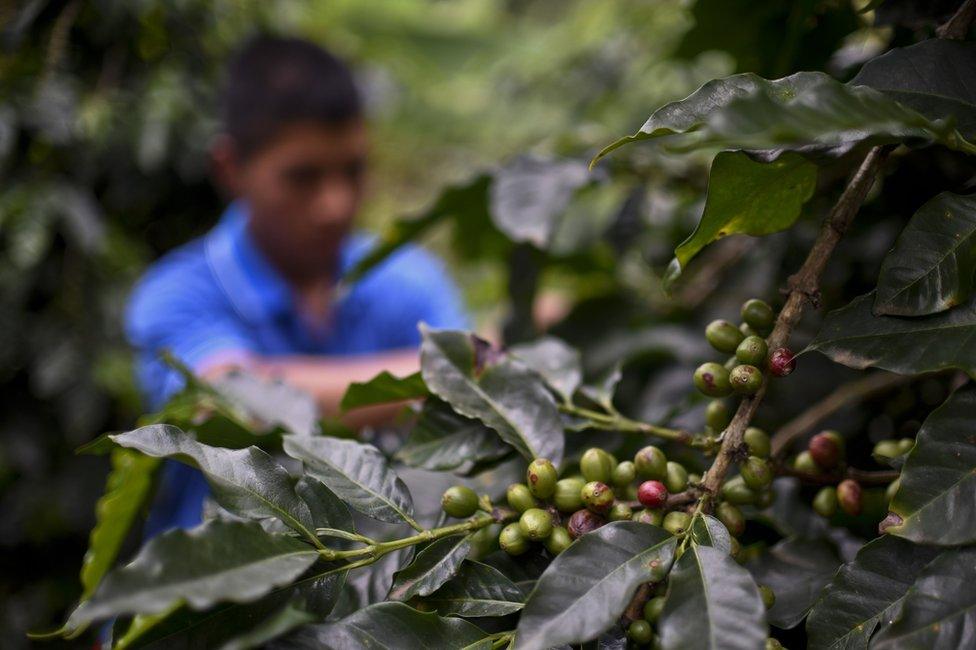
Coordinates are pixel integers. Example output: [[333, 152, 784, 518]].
[[214, 120, 367, 281]]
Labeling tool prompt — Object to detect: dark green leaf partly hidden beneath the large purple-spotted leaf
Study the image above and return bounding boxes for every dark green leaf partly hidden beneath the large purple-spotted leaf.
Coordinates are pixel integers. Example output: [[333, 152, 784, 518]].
[[395, 398, 512, 472]]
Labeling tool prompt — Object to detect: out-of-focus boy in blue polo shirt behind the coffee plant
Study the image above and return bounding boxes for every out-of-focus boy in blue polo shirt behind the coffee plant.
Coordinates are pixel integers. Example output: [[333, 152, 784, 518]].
[[126, 36, 466, 535]]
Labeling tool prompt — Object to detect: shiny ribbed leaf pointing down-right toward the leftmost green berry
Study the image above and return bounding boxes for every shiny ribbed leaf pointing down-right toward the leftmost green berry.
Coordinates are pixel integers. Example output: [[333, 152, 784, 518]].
[[284, 436, 420, 530]]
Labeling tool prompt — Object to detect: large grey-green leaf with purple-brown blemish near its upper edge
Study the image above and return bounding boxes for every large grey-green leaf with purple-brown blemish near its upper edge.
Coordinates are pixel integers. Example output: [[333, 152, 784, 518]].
[[420, 325, 565, 465]]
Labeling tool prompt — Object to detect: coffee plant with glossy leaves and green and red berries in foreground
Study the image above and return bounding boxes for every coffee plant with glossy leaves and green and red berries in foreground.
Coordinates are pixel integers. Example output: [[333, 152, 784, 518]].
[[30, 1, 976, 649]]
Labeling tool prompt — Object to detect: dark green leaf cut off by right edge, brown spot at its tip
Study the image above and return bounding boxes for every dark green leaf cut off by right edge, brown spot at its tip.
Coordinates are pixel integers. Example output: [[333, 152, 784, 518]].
[[885, 387, 976, 546]]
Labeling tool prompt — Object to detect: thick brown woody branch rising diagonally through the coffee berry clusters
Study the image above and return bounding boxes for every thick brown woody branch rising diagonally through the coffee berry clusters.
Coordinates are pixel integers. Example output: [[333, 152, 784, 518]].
[[701, 147, 889, 502]]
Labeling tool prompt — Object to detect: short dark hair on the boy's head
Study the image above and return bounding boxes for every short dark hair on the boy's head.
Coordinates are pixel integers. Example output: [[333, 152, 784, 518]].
[[222, 36, 362, 156]]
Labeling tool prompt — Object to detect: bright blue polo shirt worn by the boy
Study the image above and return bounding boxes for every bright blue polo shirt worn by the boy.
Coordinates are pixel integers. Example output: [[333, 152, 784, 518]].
[[125, 204, 467, 535]]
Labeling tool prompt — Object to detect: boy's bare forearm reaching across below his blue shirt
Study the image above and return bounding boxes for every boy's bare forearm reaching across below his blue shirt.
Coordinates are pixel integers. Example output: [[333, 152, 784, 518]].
[[201, 348, 420, 428]]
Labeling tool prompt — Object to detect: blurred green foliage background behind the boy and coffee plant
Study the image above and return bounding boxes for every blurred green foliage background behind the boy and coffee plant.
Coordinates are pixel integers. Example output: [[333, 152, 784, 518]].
[[0, 0, 968, 648]]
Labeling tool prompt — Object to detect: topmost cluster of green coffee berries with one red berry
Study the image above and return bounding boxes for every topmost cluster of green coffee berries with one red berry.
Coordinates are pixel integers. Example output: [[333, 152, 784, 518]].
[[694, 298, 796, 397]]
